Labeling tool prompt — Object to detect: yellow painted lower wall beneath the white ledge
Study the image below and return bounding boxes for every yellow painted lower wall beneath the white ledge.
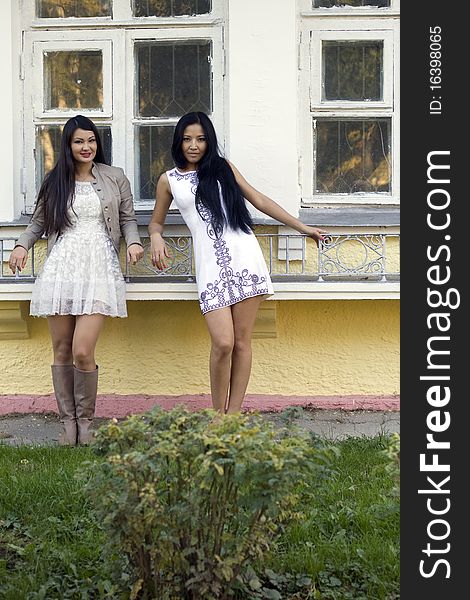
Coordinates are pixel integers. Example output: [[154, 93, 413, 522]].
[[0, 300, 399, 396]]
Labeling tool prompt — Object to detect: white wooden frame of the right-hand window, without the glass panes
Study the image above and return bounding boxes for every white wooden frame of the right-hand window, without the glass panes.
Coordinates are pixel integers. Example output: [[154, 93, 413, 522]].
[[299, 0, 400, 208]]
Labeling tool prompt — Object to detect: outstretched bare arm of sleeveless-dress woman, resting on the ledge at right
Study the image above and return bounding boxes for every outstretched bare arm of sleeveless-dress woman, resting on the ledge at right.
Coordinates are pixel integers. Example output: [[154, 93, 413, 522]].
[[227, 161, 327, 242]]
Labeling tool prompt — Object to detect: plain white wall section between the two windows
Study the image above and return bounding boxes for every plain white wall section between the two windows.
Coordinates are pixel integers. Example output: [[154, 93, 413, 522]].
[[226, 0, 299, 216]]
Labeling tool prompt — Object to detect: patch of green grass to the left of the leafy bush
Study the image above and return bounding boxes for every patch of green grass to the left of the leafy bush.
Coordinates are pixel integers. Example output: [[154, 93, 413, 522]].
[[0, 445, 111, 600]]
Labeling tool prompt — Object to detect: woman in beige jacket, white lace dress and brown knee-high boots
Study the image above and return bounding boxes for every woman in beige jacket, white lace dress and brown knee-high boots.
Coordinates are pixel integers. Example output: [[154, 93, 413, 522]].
[[9, 115, 143, 445]]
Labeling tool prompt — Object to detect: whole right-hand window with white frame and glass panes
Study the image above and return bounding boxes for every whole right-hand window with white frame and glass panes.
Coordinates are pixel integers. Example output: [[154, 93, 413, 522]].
[[300, 0, 399, 206]]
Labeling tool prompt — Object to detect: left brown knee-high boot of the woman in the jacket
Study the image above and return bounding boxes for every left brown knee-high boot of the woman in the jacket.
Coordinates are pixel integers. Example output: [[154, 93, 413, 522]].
[[51, 365, 77, 446]]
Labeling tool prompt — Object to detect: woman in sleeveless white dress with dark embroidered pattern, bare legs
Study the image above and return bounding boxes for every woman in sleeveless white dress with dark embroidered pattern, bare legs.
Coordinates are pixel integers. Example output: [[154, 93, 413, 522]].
[[149, 112, 326, 413]]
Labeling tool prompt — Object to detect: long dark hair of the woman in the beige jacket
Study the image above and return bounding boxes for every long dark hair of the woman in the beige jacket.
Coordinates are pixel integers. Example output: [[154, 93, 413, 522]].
[[37, 115, 106, 235]]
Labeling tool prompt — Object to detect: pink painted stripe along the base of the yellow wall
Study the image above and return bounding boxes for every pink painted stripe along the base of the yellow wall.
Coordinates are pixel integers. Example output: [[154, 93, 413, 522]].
[[0, 394, 400, 418]]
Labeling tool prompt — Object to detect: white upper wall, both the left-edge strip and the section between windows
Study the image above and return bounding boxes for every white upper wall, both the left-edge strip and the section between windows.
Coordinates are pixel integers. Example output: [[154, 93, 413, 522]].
[[0, 0, 299, 221]]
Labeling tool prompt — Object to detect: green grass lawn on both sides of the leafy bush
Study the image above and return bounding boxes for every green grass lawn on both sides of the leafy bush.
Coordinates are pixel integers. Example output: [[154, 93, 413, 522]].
[[0, 436, 399, 600]]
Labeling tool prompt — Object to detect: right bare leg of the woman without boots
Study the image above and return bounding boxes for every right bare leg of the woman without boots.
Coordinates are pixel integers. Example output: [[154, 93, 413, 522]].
[[226, 296, 263, 414]]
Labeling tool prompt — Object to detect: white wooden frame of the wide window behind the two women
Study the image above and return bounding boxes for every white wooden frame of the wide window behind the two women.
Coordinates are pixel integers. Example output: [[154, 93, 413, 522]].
[[20, 0, 226, 213]]
